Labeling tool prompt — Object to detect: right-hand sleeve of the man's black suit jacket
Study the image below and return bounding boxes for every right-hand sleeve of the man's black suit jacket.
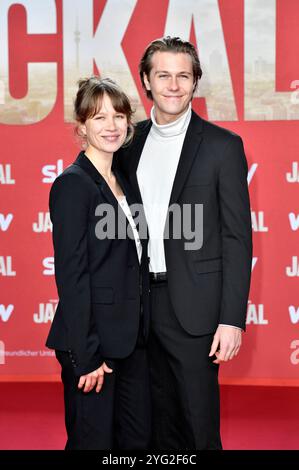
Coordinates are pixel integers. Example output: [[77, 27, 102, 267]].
[[218, 136, 252, 330]]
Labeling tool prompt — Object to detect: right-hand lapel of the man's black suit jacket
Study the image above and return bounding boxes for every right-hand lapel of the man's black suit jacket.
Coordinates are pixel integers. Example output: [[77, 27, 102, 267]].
[[169, 111, 202, 205]]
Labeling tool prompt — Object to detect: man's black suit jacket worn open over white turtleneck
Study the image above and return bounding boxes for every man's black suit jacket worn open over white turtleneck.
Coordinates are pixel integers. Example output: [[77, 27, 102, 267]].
[[116, 111, 252, 335]]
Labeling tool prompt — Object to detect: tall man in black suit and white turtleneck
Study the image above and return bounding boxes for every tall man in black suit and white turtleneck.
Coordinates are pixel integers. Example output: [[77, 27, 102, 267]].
[[119, 37, 252, 450]]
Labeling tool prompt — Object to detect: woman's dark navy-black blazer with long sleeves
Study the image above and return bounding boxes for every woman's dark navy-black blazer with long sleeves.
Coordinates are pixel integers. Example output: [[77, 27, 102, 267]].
[[46, 152, 148, 376]]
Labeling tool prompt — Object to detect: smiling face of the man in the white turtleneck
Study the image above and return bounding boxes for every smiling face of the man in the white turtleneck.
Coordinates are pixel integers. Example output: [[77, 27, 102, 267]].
[[144, 52, 194, 124]]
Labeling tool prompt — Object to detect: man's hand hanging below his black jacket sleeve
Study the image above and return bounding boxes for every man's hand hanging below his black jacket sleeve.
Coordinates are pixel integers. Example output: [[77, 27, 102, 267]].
[[209, 325, 242, 364]]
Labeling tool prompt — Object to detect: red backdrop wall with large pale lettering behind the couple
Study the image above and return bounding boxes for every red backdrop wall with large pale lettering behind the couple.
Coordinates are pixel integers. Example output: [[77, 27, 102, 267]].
[[0, 0, 299, 385]]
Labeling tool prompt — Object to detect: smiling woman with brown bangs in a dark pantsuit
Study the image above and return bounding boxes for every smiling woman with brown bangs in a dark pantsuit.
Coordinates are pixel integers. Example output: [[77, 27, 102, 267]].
[[47, 77, 150, 449]]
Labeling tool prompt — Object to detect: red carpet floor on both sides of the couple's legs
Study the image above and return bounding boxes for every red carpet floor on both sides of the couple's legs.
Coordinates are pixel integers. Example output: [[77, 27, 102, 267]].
[[0, 383, 299, 450]]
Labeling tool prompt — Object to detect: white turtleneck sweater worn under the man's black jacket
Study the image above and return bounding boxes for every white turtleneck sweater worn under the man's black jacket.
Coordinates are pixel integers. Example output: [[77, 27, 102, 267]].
[[137, 104, 191, 273]]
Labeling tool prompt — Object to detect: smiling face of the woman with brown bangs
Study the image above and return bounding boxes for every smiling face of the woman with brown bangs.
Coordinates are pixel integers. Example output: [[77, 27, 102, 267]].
[[81, 94, 128, 154]]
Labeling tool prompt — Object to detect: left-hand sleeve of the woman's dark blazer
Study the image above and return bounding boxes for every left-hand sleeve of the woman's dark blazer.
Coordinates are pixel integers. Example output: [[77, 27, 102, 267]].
[[50, 174, 103, 376]]
